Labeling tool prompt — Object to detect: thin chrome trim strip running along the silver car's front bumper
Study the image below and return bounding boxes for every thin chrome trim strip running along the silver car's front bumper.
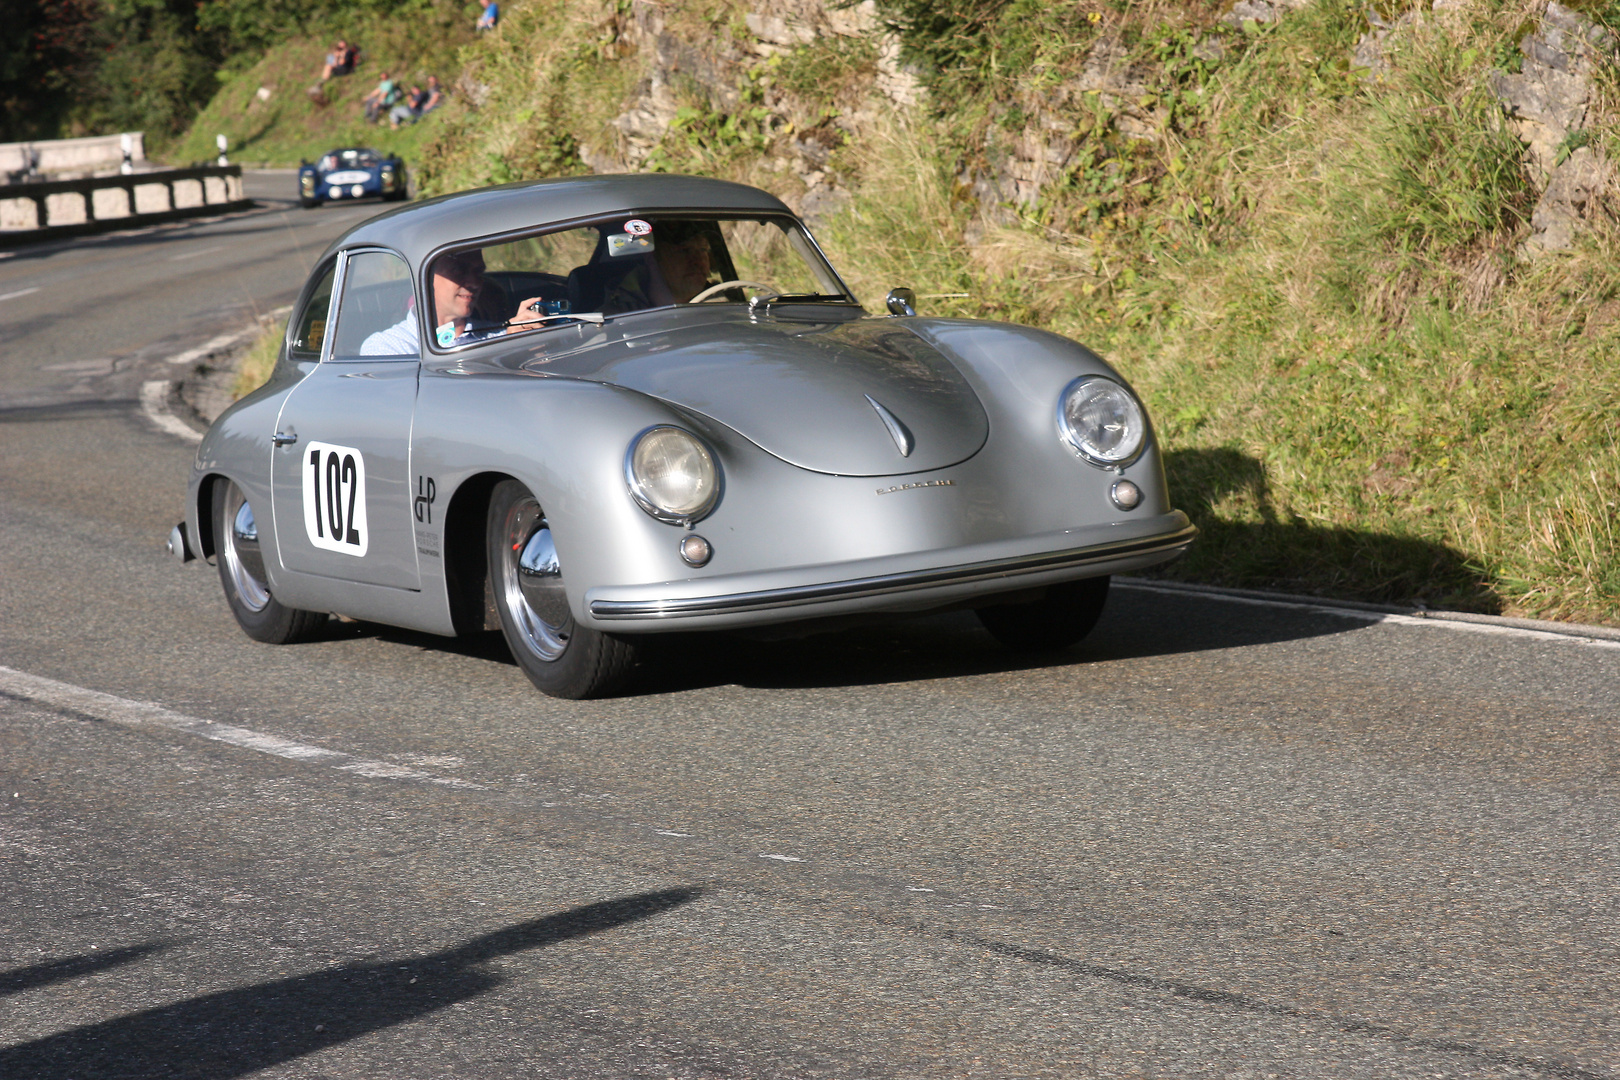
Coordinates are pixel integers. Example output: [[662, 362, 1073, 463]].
[[588, 513, 1199, 620]]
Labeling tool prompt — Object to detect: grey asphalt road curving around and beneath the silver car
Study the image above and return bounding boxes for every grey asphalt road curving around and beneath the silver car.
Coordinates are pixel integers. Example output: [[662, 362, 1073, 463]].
[[0, 176, 1620, 1080]]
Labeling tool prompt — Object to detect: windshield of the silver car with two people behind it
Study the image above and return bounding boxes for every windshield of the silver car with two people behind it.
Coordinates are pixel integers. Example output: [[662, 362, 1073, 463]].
[[429, 214, 855, 348]]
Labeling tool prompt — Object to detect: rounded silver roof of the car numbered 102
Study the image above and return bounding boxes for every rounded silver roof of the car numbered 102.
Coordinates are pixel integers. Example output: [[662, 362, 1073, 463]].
[[327, 173, 792, 266]]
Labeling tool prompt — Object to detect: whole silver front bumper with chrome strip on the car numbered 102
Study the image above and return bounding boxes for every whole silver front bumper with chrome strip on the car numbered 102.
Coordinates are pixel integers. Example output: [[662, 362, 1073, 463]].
[[585, 510, 1197, 631]]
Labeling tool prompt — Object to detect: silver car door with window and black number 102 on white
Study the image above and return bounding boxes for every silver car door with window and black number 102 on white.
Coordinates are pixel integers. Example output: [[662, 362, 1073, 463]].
[[271, 248, 421, 589]]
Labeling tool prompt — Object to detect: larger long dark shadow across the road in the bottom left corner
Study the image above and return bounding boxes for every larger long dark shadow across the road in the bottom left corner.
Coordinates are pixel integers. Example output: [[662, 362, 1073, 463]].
[[0, 887, 703, 1080]]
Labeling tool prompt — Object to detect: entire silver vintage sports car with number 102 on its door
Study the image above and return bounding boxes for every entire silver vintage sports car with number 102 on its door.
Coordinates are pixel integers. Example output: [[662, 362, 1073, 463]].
[[170, 176, 1196, 698]]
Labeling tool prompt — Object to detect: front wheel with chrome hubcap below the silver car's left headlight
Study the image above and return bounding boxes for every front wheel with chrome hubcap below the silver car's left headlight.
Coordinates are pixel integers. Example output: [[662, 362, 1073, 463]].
[[484, 479, 638, 699]]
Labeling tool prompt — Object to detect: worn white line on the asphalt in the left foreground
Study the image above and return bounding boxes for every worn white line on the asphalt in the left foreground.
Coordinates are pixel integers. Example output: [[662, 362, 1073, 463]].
[[0, 667, 484, 790]]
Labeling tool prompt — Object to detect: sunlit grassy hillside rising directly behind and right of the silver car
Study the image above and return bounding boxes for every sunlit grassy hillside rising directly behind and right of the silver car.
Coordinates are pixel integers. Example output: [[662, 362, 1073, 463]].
[[192, 0, 1620, 623]]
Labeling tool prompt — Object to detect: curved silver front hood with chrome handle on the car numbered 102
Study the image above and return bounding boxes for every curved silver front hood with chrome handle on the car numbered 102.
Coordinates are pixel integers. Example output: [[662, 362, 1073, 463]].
[[546, 319, 990, 476]]
